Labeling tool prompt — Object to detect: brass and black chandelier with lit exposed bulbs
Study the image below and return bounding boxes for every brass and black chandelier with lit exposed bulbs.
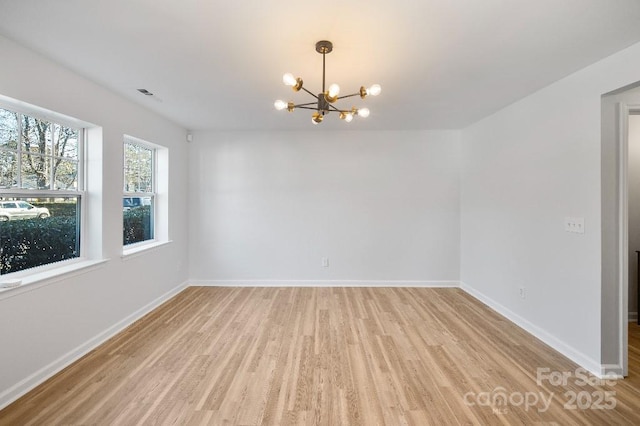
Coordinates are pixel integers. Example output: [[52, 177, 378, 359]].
[[273, 40, 382, 124]]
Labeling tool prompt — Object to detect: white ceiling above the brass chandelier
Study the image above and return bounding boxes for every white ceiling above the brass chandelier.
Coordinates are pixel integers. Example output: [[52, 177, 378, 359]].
[[0, 0, 640, 130]]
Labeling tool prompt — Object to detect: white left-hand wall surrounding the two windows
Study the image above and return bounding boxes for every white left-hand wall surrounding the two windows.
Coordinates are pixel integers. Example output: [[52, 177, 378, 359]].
[[0, 37, 188, 407]]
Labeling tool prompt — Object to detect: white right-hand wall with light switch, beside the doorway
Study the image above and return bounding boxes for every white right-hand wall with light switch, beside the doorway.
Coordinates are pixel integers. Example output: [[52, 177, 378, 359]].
[[461, 40, 640, 372]]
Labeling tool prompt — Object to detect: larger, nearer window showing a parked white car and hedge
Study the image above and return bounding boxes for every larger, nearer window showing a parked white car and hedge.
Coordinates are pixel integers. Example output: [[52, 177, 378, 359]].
[[0, 107, 84, 275]]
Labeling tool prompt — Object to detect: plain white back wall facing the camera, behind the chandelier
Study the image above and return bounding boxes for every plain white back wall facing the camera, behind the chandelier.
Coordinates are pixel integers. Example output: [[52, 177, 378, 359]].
[[190, 127, 459, 285]]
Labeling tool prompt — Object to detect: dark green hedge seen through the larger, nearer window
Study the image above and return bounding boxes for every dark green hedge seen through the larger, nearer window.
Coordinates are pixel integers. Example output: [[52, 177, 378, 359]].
[[0, 215, 79, 274]]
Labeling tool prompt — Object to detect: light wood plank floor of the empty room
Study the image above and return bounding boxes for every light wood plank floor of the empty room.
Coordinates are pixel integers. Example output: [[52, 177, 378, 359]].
[[0, 287, 640, 426]]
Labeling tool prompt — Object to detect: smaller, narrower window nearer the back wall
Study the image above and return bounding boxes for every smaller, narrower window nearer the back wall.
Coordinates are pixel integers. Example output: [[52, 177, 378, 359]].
[[122, 137, 157, 246]]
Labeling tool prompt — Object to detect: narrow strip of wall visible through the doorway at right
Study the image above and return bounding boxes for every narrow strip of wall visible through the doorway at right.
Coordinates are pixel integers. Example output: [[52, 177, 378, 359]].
[[629, 115, 640, 315]]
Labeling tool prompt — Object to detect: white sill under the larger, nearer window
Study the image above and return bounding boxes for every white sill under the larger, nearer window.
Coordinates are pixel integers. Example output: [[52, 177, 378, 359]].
[[0, 259, 109, 300]]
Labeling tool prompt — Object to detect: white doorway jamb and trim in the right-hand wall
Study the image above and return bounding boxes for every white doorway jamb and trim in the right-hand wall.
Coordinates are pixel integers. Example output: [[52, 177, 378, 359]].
[[600, 82, 640, 376]]
